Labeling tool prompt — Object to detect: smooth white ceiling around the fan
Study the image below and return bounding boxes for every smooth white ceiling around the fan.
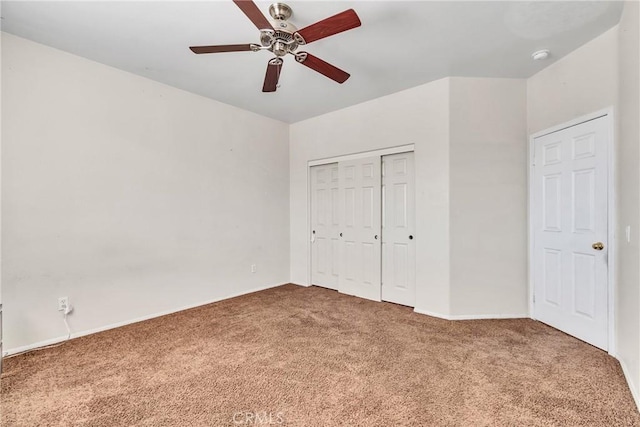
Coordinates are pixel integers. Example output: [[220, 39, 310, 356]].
[[1, 0, 623, 123]]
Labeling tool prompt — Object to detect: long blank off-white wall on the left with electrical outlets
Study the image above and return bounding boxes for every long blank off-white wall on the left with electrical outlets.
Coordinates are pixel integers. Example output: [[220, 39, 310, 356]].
[[2, 34, 289, 349]]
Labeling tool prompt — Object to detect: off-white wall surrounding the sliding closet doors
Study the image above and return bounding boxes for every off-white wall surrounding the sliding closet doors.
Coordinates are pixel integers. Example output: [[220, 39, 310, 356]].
[[290, 79, 449, 313]]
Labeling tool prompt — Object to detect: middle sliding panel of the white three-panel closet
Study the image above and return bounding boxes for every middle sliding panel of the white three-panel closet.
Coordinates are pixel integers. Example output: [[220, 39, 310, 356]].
[[338, 156, 381, 301]]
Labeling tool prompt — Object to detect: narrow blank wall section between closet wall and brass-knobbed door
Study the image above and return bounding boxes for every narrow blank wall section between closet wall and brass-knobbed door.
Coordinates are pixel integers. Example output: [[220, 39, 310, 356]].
[[449, 77, 528, 317]]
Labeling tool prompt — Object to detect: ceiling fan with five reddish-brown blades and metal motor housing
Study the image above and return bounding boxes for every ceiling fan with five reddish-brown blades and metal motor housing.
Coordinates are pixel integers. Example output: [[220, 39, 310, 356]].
[[189, 0, 361, 92]]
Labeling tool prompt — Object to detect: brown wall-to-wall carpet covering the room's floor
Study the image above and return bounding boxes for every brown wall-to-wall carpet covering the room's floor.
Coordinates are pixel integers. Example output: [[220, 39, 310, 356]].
[[2, 285, 640, 427]]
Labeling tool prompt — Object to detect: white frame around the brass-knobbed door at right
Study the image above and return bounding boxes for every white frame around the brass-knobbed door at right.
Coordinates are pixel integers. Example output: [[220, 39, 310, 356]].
[[527, 107, 617, 357]]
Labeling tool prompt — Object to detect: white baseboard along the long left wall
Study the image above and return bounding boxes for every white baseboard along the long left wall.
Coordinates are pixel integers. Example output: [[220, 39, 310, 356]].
[[2, 283, 288, 357]]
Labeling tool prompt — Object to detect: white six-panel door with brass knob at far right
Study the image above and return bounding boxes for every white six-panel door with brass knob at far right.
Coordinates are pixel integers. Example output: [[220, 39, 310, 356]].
[[532, 117, 609, 350]]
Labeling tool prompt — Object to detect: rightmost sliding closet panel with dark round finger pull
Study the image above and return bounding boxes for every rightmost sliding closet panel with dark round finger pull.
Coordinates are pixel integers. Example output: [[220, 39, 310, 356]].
[[382, 152, 416, 307]]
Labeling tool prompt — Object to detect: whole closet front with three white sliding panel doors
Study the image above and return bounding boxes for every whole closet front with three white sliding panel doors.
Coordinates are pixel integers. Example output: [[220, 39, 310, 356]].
[[310, 152, 415, 307]]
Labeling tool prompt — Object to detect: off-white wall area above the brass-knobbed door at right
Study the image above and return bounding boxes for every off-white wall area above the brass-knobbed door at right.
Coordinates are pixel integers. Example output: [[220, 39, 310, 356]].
[[527, 27, 618, 135]]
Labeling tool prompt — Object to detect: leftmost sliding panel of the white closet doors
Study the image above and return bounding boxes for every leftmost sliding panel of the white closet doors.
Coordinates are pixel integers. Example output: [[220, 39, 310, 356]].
[[311, 163, 340, 290]]
